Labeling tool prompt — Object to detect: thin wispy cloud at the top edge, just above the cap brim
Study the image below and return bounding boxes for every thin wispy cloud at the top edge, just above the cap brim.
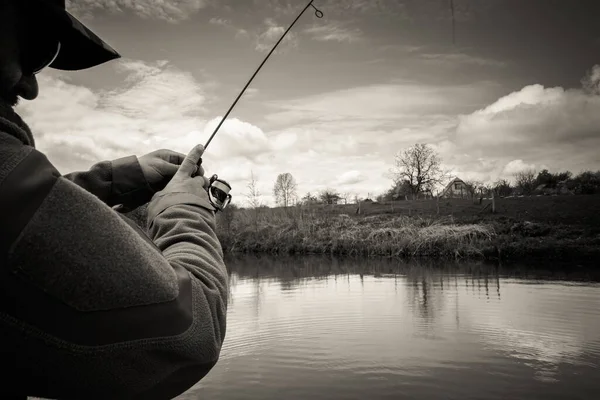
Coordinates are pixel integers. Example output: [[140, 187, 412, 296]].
[[66, 0, 208, 23]]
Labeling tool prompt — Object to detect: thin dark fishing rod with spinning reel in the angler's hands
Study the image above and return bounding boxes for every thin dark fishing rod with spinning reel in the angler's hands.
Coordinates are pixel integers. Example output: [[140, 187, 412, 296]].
[[193, 0, 323, 211]]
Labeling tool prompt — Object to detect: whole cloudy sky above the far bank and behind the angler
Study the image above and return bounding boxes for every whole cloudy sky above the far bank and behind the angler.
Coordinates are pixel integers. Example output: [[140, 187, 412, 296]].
[[12, 0, 600, 206]]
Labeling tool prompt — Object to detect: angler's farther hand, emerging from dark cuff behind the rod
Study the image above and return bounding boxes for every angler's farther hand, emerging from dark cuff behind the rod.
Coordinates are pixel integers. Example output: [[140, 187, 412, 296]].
[[138, 149, 185, 192]]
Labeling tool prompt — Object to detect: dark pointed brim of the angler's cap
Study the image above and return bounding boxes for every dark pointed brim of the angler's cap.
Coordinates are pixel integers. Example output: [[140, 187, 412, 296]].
[[30, 0, 121, 71]]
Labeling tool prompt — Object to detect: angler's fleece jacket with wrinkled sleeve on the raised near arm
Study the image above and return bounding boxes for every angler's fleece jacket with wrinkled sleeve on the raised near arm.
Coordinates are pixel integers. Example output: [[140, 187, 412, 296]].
[[0, 104, 228, 400]]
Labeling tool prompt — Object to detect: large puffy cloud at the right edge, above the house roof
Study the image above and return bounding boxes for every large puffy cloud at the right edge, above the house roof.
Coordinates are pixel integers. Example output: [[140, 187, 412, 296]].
[[455, 67, 600, 173]]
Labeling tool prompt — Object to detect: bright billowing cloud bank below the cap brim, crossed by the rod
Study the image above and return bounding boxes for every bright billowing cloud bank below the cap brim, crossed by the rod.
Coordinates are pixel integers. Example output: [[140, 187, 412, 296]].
[[17, 61, 270, 173]]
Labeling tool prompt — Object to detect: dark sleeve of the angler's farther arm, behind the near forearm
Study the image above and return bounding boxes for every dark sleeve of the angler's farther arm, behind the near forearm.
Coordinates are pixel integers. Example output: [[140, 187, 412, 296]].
[[63, 156, 154, 209]]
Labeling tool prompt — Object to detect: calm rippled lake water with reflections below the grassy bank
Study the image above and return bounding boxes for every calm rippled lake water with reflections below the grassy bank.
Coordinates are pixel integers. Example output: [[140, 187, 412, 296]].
[[178, 257, 600, 400]]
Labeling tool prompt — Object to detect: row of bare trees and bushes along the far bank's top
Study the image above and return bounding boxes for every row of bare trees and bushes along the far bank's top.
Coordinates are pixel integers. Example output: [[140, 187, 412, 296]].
[[241, 143, 600, 208]]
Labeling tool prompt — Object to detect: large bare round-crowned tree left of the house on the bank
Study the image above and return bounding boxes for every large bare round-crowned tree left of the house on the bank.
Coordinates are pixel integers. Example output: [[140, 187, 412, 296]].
[[390, 143, 448, 198]]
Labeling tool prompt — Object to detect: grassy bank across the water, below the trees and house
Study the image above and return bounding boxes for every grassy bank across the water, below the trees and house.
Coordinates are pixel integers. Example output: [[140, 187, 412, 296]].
[[213, 196, 600, 263]]
